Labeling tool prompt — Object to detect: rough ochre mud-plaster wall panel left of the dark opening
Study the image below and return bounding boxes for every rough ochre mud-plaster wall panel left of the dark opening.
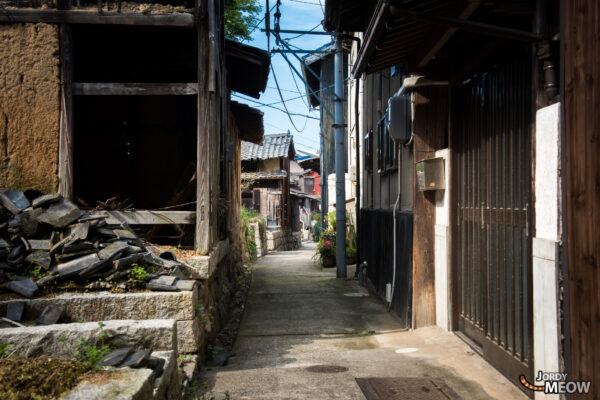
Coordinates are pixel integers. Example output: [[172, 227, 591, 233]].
[[0, 24, 60, 192]]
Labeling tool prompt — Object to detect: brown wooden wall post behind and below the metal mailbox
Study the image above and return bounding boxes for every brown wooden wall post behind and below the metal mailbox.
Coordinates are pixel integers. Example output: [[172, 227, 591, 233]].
[[412, 87, 448, 329]]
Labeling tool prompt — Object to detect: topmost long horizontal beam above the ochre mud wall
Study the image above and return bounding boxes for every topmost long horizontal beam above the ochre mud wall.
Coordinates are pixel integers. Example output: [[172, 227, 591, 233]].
[[0, 9, 196, 27]]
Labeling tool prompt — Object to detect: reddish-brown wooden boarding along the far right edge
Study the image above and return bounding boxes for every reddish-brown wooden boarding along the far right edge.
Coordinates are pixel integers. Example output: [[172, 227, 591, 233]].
[[563, 0, 600, 399]]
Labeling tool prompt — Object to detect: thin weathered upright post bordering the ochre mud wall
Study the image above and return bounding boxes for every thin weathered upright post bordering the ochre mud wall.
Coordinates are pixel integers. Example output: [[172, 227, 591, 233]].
[[58, 24, 73, 198]]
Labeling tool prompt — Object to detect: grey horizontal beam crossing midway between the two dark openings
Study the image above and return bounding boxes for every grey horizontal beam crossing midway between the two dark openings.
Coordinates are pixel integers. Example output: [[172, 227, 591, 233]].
[[73, 82, 198, 96]]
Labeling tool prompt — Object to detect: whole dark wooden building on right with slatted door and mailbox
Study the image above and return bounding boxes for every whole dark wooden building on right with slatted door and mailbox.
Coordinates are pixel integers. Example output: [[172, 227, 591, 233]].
[[325, 0, 600, 398]]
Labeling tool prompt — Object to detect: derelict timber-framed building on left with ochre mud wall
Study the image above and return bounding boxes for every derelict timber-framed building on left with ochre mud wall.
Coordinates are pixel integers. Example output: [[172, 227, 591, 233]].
[[0, 0, 270, 260]]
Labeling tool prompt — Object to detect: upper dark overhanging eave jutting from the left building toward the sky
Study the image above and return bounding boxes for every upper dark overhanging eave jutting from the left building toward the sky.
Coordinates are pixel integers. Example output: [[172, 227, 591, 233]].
[[225, 39, 271, 99]]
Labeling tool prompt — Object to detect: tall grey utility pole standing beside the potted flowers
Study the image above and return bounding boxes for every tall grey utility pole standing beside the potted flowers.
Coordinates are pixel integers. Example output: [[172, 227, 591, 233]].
[[333, 32, 347, 278]]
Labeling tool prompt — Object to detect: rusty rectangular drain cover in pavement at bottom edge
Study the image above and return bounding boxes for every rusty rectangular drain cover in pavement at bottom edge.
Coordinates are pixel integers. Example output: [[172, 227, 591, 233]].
[[356, 378, 459, 400]]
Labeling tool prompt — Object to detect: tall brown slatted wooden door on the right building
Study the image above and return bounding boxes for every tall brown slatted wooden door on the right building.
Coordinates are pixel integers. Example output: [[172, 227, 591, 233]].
[[452, 57, 533, 380]]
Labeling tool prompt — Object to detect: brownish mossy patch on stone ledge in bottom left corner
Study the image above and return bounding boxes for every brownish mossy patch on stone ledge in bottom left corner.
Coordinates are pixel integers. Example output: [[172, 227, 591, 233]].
[[0, 357, 89, 400]]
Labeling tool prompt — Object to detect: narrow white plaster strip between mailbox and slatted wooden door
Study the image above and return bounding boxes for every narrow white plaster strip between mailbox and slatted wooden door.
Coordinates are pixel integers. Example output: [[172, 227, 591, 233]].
[[434, 149, 450, 331]]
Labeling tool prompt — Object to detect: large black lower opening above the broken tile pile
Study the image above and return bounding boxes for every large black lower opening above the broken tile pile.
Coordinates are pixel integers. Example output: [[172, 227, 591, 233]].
[[73, 96, 196, 210]]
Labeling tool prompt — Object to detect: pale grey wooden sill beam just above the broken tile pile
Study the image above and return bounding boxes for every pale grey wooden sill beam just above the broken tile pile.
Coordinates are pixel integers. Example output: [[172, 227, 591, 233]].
[[89, 210, 196, 225]]
